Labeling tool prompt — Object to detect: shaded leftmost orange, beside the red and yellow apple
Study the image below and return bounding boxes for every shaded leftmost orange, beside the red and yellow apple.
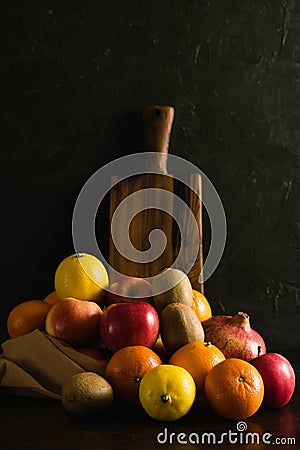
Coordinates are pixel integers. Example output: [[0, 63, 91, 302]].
[[7, 300, 51, 338]]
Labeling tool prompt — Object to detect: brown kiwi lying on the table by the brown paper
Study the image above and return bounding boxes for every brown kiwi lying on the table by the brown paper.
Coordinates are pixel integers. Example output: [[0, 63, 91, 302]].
[[61, 372, 113, 416]]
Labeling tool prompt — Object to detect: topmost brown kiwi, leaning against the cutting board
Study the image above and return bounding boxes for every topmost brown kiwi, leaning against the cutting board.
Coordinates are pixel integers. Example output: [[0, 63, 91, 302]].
[[152, 268, 193, 312]]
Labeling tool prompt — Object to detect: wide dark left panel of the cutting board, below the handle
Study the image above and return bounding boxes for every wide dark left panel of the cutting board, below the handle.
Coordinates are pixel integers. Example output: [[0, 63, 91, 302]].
[[109, 174, 173, 281]]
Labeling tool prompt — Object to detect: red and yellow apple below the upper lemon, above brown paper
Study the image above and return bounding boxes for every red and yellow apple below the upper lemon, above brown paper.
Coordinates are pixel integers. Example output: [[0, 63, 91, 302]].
[[45, 297, 102, 346]]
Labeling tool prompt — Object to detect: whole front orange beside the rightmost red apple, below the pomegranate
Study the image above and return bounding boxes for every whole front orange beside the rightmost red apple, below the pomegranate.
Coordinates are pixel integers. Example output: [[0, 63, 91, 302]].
[[204, 358, 264, 420]]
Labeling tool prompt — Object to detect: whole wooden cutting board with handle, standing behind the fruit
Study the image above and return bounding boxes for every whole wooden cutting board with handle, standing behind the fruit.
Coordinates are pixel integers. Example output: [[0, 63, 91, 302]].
[[109, 106, 203, 292]]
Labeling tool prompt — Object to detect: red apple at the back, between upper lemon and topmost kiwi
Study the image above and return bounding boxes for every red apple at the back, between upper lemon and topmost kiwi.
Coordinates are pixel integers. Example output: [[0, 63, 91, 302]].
[[104, 277, 152, 306]]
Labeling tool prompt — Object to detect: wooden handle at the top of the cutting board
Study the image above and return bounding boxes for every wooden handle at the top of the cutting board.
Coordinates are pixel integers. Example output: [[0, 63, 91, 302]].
[[143, 106, 174, 174]]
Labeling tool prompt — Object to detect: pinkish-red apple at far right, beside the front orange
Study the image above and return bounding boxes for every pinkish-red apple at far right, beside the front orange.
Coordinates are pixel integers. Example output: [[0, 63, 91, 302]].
[[250, 353, 295, 409]]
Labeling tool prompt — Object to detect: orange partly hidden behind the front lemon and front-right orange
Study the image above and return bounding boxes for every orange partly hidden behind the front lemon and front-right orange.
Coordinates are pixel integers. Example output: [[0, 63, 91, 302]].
[[169, 342, 225, 406]]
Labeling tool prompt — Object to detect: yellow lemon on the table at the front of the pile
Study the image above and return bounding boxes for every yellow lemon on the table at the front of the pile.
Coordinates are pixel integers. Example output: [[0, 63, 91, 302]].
[[139, 364, 196, 421]]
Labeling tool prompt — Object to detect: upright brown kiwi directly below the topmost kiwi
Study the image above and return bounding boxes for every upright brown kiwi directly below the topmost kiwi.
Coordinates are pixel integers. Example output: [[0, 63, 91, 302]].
[[160, 303, 204, 355]]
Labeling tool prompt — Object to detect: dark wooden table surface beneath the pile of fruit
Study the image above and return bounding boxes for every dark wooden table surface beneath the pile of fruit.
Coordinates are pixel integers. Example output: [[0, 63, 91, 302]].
[[0, 353, 300, 450]]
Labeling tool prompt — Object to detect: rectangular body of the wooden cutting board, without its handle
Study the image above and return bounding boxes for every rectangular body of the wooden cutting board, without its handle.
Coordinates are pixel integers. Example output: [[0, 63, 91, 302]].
[[109, 174, 204, 292]]
